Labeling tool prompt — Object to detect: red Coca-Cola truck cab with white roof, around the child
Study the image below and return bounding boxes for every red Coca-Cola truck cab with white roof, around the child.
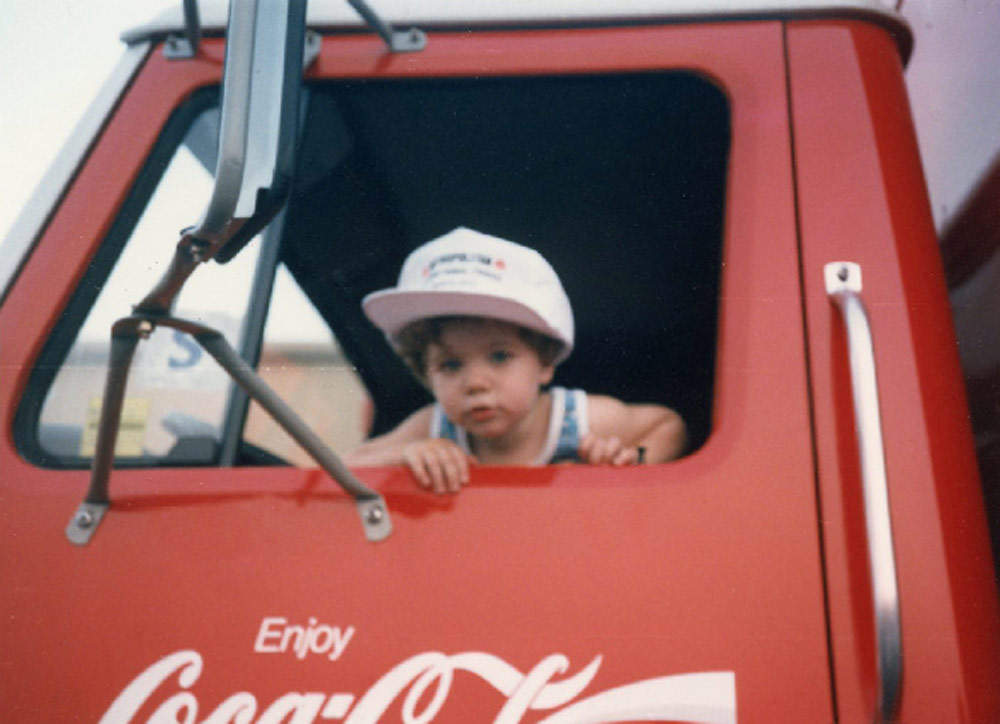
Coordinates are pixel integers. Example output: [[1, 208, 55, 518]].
[[0, 0, 1000, 724]]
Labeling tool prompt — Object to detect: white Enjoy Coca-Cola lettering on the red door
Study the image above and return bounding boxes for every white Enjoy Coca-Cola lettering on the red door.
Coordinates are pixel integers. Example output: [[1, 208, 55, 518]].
[[101, 616, 736, 724]]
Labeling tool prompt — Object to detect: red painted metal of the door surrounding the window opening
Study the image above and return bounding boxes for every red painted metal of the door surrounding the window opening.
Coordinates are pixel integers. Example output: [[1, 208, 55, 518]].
[[0, 23, 833, 722]]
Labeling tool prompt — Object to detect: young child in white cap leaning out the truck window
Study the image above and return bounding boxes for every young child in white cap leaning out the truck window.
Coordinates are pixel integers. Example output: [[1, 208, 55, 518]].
[[345, 228, 685, 493]]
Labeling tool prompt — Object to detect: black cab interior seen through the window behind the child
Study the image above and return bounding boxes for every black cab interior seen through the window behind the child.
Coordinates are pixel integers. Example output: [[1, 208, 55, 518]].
[[281, 73, 729, 456]]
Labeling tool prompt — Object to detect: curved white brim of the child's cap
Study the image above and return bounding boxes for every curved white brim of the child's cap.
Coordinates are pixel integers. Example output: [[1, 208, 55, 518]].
[[361, 289, 572, 362]]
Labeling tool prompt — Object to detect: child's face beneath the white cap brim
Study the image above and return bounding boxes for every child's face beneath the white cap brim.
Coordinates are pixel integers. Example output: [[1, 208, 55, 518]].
[[427, 320, 554, 439]]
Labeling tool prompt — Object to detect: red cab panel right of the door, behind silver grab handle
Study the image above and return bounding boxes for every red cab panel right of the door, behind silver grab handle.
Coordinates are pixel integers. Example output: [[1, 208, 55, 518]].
[[788, 23, 1000, 722]]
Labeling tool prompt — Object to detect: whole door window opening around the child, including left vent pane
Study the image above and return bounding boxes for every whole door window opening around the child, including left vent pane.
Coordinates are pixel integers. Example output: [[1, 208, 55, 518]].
[[18, 72, 729, 467]]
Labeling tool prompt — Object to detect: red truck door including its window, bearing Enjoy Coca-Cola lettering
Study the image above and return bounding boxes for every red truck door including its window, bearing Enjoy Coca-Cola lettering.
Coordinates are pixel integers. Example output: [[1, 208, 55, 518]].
[[0, 22, 835, 722]]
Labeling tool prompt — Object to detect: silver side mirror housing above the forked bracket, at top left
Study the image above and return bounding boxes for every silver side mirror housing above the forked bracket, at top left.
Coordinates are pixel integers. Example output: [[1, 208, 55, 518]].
[[189, 0, 306, 262]]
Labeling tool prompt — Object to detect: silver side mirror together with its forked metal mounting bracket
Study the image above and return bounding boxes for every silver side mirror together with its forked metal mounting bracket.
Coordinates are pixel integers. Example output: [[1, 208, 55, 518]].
[[66, 0, 392, 545]]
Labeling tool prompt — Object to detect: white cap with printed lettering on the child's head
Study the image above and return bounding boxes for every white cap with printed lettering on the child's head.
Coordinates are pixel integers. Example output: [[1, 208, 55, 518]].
[[361, 227, 573, 364]]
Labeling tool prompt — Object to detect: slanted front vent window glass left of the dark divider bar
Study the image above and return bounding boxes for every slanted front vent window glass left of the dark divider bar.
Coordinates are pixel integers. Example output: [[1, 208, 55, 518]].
[[38, 100, 258, 466]]
